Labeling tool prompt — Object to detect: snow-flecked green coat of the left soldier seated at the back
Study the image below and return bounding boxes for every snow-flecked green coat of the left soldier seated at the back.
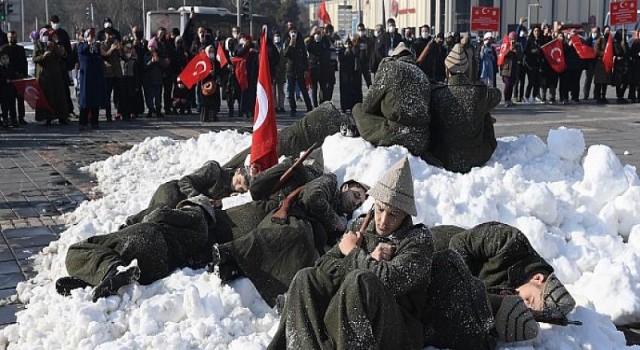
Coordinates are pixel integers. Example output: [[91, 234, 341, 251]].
[[353, 55, 431, 160]]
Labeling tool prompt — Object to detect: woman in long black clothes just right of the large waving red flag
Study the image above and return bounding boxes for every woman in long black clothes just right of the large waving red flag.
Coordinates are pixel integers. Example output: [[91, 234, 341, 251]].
[[197, 44, 220, 122]]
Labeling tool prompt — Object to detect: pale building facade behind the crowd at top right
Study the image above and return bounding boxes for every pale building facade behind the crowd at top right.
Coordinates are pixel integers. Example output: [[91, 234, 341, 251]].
[[306, 0, 610, 35]]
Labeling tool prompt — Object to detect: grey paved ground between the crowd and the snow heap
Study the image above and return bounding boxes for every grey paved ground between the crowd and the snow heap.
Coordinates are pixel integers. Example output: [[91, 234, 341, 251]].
[[0, 94, 640, 344]]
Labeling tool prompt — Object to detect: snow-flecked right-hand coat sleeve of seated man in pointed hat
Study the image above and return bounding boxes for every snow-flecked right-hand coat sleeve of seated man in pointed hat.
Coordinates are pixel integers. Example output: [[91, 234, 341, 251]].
[[343, 227, 433, 296]]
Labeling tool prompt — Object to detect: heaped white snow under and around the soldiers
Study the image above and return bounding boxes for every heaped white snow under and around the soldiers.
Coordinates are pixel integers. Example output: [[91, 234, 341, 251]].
[[0, 128, 640, 349]]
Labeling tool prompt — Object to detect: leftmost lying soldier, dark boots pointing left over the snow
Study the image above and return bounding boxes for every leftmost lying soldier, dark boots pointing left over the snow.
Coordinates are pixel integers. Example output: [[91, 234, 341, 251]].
[[56, 195, 216, 301]]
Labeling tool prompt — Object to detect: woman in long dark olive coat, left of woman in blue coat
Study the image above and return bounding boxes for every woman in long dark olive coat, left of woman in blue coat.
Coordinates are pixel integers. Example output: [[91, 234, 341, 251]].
[[33, 28, 69, 125]]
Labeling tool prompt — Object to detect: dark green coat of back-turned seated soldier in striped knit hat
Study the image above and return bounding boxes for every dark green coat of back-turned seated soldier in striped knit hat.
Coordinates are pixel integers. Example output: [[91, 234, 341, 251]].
[[429, 74, 501, 173]]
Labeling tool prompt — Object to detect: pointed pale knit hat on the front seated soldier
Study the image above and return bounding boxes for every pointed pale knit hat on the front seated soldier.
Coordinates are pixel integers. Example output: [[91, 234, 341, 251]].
[[367, 157, 418, 216]]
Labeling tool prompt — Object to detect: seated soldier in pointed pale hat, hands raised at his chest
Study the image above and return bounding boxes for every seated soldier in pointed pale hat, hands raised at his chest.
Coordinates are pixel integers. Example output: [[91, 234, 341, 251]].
[[269, 158, 433, 349]]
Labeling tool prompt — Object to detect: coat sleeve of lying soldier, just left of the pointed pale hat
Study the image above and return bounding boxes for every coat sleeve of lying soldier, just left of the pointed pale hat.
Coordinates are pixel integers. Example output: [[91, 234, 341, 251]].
[[301, 174, 340, 232]]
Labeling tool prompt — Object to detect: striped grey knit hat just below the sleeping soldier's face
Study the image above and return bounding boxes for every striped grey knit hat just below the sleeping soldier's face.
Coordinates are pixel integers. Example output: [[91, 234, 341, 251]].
[[494, 295, 540, 342]]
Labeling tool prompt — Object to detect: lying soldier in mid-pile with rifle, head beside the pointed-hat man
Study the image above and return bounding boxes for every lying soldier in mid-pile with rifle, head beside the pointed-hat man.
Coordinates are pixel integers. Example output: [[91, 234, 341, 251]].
[[205, 174, 367, 306]]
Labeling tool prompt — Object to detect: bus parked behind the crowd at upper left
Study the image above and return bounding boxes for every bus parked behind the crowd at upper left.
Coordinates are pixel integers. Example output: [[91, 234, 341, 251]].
[[145, 6, 275, 40]]
